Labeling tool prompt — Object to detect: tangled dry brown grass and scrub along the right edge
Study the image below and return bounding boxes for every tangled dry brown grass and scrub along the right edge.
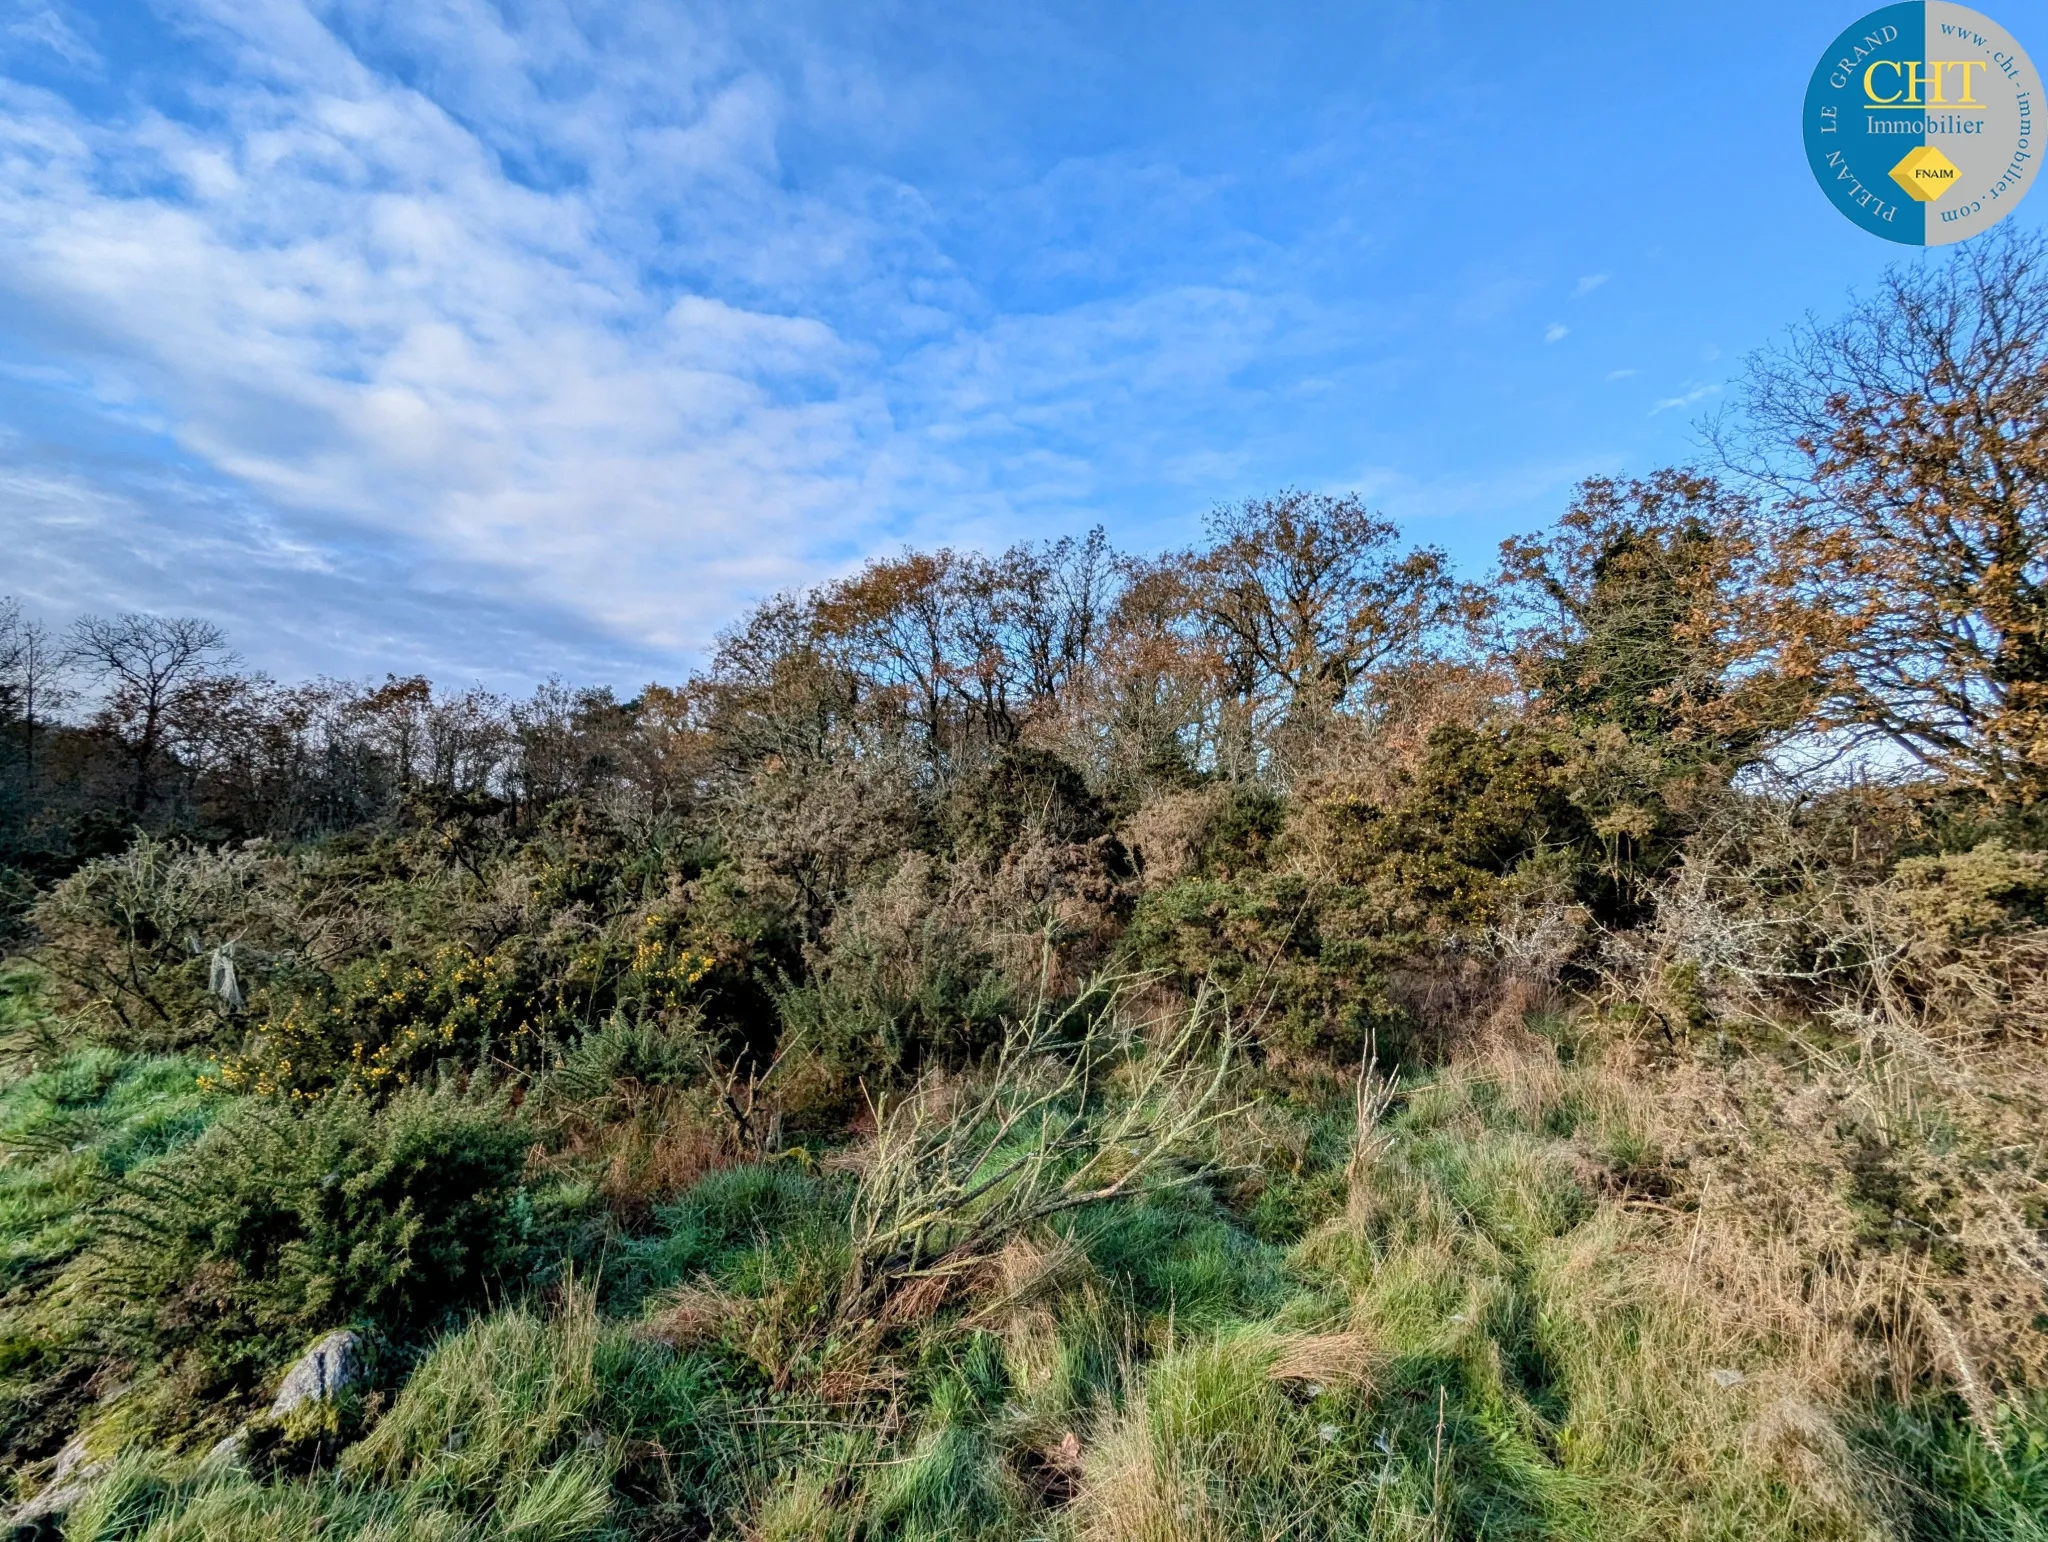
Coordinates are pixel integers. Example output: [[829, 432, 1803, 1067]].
[[1581, 809, 2048, 1440]]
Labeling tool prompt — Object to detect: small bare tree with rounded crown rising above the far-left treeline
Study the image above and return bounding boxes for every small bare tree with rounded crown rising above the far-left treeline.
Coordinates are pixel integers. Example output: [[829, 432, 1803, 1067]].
[[70, 614, 233, 817]]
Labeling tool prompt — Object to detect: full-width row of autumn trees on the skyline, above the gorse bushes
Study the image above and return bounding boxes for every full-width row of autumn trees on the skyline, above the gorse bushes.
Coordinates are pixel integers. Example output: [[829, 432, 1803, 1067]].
[[0, 238, 2048, 884]]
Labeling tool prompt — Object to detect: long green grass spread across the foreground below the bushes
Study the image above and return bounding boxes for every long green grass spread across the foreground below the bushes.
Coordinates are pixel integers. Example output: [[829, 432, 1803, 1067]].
[[0, 1023, 2048, 1542]]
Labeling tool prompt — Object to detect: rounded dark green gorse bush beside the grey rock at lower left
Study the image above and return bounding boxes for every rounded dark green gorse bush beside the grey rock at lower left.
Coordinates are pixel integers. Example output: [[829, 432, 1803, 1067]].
[[66, 1089, 537, 1395]]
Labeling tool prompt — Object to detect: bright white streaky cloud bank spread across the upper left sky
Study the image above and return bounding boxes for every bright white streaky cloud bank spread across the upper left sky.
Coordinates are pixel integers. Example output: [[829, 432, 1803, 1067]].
[[0, 0, 1343, 667]]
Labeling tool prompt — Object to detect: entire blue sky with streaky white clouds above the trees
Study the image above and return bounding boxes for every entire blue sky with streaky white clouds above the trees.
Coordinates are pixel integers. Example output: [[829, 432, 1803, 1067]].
[[0, 0, 2048, 686]]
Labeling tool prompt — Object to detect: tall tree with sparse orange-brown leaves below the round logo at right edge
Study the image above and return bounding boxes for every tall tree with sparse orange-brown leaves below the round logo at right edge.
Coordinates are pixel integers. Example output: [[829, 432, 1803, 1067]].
[[1718, 227, 2048, 803]]
